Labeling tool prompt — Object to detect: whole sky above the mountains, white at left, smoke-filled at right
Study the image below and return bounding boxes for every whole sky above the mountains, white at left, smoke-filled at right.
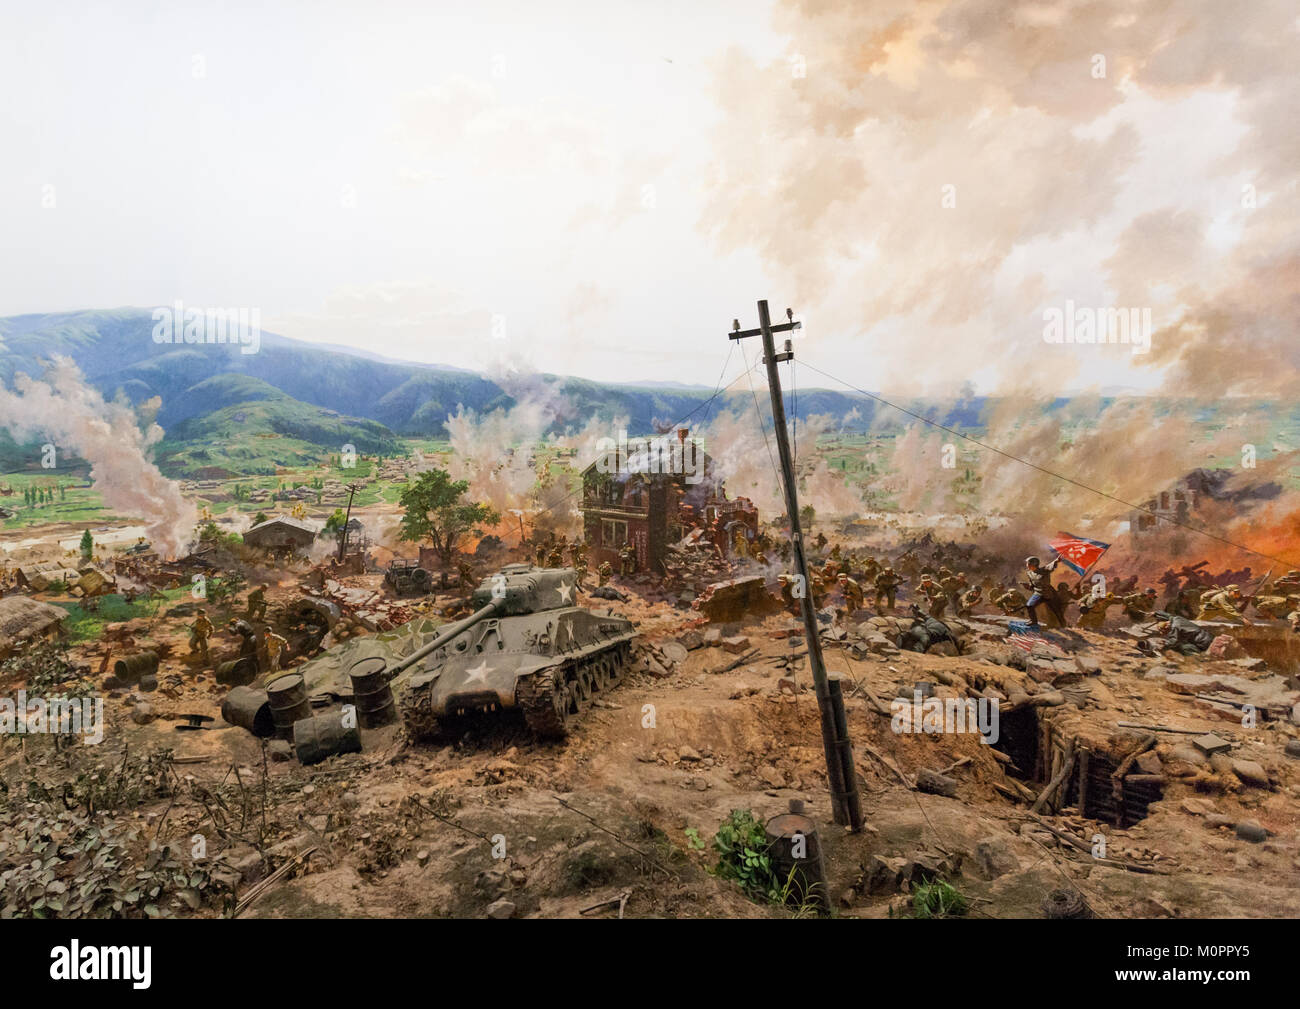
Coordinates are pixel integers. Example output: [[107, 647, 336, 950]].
[[0, 0, 1300, 397]]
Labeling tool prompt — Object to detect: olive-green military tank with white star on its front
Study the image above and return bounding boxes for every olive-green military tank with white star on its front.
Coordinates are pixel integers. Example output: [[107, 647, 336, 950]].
[[368, 564, 636, 740]]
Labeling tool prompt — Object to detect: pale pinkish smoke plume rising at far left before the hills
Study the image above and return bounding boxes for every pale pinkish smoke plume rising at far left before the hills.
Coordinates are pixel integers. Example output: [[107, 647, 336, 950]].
[[0, 356, 198, 557]]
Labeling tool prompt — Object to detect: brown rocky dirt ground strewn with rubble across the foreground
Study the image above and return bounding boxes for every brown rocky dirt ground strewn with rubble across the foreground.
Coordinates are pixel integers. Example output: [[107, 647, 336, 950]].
[[0, 572, 1300, 918]]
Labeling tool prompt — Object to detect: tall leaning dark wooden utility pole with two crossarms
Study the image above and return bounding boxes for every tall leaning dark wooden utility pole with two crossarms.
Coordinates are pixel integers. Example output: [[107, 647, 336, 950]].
[[729, 302, 862, 831]]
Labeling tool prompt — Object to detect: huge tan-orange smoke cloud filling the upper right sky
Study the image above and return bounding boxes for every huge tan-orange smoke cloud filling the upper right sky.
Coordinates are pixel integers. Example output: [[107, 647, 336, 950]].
[[703, 0, 1300, 398]]
